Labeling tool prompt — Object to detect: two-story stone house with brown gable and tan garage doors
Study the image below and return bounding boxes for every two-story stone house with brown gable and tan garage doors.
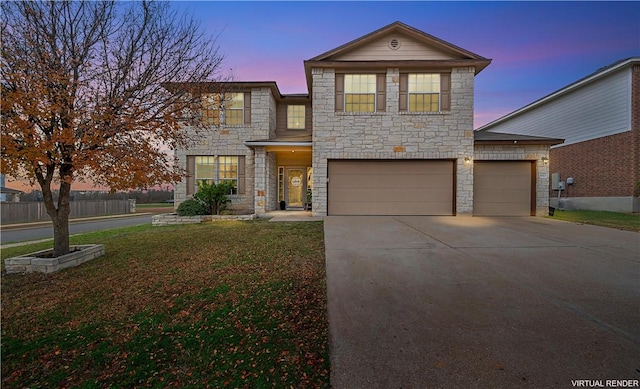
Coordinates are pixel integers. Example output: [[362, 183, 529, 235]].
[[175, 22, 561, 216]]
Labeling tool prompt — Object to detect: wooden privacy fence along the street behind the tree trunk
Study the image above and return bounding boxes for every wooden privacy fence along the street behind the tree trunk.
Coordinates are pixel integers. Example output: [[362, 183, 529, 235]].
[[0, 200, 136, 224]]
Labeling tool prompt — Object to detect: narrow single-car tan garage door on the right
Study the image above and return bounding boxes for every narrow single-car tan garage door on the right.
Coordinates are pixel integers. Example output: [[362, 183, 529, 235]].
[[473, 161, 535, 216]]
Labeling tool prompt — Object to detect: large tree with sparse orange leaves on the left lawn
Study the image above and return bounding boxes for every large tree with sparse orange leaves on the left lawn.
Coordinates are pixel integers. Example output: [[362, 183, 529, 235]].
[[0, 1, 228, 256]]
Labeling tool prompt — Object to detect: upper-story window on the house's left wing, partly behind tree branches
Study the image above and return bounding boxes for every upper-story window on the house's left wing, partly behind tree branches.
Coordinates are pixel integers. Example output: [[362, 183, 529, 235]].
[[202, 93, 251, 126]]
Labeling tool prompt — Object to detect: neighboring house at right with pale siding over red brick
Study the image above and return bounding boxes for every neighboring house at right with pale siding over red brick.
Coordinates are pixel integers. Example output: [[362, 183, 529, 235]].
[[478, 57, 640, 212]]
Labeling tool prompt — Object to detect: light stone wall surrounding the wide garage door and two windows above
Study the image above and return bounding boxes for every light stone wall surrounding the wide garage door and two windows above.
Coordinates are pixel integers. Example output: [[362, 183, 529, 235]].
[[312, 67, 474, 216]]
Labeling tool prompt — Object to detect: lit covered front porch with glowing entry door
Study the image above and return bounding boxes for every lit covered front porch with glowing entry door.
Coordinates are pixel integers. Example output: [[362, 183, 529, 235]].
[[244, 135, 313, 215]]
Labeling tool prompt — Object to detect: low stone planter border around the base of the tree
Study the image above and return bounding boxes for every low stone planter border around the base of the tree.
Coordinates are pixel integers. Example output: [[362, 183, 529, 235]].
[[4, 244, 104, 274]]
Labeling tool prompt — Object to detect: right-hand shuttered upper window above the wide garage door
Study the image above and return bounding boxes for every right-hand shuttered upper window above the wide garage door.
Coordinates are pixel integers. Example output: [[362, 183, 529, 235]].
[[399, 73, 451, 112]]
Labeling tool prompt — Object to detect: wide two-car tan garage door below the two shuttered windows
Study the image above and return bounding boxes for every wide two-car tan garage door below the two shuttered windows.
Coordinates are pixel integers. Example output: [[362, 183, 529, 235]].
[[327, 160, 454, 215]]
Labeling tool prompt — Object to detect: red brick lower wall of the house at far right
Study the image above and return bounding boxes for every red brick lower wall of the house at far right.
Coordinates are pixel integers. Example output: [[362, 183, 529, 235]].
[[549, 130, 638, 197]]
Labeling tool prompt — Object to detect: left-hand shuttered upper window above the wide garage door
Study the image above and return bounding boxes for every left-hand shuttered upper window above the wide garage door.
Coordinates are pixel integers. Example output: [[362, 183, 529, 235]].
[[335, 73, 386, 113]]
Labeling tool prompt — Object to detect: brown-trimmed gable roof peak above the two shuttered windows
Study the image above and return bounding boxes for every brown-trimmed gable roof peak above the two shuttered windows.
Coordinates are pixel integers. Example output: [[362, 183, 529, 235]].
[[304, 22, 491, 92]]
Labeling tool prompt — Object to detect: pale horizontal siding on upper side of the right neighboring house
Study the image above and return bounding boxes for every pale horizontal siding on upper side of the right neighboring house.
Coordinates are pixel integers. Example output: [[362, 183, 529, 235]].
[[487, 68, 631, 147]]
